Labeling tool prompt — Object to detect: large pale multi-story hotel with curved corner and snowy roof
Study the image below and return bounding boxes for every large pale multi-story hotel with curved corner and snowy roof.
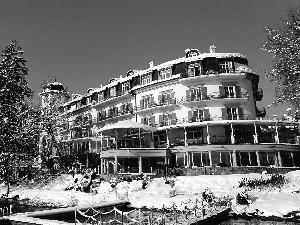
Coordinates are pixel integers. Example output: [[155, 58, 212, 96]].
[[56, 46, 300, 173]]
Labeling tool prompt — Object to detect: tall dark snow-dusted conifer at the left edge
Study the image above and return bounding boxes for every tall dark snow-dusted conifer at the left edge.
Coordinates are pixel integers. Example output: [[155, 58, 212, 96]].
[[0, 41, 38, 195]]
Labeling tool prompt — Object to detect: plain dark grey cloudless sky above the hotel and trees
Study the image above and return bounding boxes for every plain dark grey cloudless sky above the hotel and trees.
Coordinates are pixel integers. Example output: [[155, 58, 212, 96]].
[[0, 0, 300, 117]]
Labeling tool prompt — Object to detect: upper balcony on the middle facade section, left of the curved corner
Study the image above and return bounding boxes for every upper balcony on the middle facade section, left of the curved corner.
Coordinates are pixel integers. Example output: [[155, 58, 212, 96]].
[[136, 98, 179, 113]]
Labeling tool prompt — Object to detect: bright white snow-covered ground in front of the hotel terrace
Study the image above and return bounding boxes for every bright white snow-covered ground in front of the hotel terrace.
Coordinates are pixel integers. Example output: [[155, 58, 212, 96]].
[[0, 170, 300, 217]]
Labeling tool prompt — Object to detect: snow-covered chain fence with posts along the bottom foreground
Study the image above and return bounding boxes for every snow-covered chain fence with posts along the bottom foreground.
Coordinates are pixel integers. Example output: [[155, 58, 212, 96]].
[[75, 197, 231, 225]]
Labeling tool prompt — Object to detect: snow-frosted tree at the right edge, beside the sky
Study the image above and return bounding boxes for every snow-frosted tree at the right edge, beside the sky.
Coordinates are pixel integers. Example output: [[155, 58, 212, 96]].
[[262, 8, 300, 114]]
